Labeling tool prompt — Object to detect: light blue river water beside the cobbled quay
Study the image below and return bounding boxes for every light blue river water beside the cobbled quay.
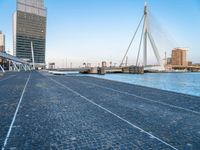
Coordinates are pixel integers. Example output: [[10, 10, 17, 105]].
[[84, 73, 200, 96]]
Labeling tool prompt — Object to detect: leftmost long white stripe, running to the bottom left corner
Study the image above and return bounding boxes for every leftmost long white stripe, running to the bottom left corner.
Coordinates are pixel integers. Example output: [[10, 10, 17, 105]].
[[2, 73, 31, 150]]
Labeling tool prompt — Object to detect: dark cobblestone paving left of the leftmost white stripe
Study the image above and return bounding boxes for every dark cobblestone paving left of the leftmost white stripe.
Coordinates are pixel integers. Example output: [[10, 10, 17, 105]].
[[0, 73, 27, 147]]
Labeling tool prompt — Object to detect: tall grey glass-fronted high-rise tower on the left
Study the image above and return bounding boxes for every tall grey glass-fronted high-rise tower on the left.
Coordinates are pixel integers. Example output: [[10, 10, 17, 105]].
[[13, 0, 47, 66]]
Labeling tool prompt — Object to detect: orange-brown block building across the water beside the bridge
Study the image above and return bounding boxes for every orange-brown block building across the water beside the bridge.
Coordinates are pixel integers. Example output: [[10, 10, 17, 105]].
[[172, 48, 188, 66]]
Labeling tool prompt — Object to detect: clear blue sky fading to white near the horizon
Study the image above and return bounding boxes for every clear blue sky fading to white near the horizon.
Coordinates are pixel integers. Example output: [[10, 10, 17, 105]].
[[0, 0, 200, 66]]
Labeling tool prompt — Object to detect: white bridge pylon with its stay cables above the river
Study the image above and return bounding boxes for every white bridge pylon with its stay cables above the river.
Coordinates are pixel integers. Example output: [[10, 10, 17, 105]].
[[120, 2, 173, 70]]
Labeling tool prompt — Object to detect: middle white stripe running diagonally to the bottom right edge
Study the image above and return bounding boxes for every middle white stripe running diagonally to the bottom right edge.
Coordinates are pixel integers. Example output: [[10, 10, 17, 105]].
[[47, 75, 178, 150]]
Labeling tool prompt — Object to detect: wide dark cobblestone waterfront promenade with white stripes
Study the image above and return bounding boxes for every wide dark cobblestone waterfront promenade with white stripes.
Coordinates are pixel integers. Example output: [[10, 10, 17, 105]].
[[0, 72, 200, 150]]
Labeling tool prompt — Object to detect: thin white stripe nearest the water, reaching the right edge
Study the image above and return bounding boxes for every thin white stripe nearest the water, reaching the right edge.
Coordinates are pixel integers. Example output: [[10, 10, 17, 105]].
[[70, 80, 200, 115]]
